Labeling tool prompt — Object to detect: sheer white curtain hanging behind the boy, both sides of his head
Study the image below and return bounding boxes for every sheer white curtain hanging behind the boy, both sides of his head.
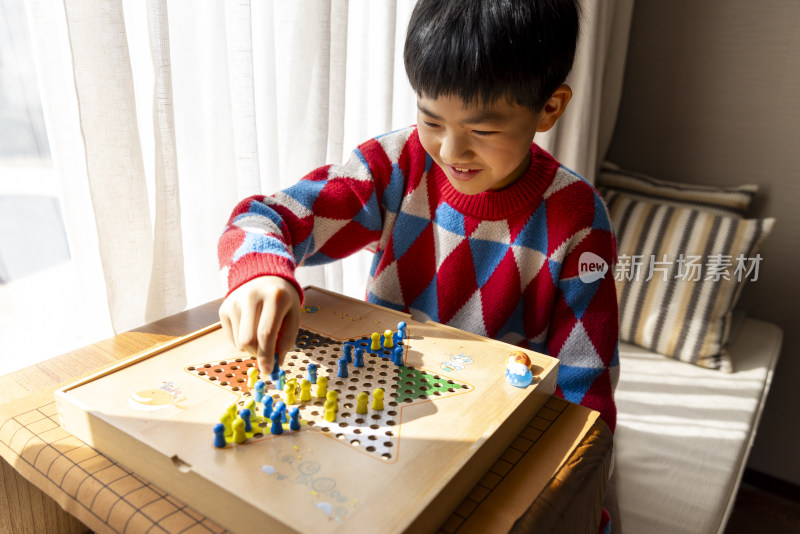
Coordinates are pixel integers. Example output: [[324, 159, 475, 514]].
[[10, 0, 633, 366]]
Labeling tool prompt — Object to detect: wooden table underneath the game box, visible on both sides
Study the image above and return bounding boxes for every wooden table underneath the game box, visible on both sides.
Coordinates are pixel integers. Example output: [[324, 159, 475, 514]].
[[0, 301, 612, 533]]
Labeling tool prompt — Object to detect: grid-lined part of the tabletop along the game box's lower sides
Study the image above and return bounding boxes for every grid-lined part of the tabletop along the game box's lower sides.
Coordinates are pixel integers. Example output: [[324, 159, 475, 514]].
[[0, 393, 569, 534]]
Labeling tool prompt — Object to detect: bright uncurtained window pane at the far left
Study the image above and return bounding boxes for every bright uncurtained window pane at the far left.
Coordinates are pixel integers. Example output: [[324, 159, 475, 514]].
[[0, 0, 111, 374]]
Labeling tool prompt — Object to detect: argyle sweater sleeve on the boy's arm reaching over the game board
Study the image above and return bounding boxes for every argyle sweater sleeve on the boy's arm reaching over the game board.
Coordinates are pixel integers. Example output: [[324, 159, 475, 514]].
[[217, 136, 392, 298]]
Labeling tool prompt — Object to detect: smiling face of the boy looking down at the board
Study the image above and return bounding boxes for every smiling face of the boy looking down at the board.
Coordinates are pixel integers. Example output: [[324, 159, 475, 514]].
[[417, 96, 542, 195]]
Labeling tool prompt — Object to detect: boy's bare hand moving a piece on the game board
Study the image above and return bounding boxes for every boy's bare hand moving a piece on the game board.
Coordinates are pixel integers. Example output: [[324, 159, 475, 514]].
[[219, 276, 300, 377]]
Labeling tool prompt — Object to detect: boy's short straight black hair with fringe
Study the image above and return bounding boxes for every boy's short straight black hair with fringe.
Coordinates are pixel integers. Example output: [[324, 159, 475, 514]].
[[403, 0, 580, 112]]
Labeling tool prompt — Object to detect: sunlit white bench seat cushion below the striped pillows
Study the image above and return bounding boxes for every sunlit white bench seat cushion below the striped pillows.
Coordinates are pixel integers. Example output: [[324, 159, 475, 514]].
[[614, 318, 782, 534]]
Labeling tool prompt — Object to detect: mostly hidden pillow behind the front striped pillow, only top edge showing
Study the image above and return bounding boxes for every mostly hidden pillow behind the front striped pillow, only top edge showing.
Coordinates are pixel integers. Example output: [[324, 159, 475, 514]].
[[597, 161, 758, 217]]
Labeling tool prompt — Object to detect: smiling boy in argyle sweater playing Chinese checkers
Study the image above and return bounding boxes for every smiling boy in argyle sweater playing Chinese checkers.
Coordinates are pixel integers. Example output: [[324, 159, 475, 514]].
[[219, 0, 618, 452]]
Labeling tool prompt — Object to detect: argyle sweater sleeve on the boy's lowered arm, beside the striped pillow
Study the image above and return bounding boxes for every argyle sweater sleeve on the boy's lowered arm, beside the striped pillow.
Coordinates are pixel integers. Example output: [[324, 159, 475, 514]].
[[546, 193, 619, 432]]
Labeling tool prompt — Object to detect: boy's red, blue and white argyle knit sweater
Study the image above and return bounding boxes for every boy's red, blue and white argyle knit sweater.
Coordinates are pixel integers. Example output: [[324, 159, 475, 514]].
[[219, 127, 619, 431]]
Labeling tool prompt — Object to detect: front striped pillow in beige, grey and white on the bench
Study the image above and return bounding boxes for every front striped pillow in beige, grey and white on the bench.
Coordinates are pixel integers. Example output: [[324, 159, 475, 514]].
[[605, 190, 775, 372]]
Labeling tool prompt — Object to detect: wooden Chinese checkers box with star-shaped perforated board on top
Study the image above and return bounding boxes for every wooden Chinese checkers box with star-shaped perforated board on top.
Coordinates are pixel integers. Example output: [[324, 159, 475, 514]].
[[56, 287, 558, 533]]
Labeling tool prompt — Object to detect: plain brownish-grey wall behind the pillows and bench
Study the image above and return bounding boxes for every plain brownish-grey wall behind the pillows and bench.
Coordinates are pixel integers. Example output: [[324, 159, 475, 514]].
[[608, 0, 800, 485]]
